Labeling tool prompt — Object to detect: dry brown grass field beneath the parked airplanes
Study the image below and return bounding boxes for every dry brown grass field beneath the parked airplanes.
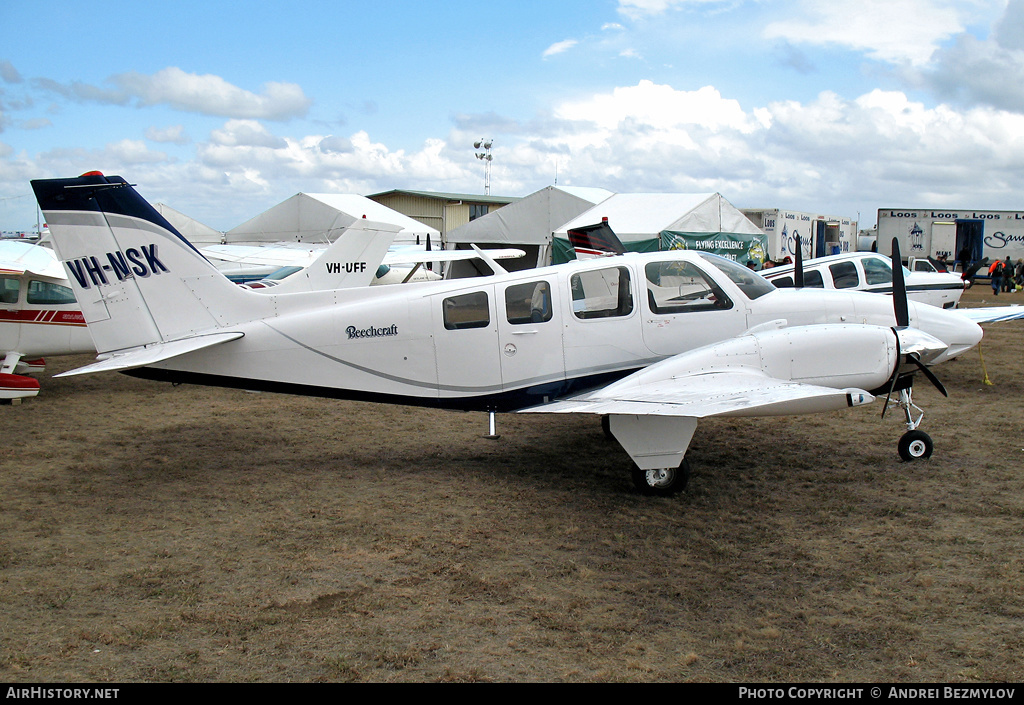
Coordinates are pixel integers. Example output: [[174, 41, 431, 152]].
[[0, 286, 1024, 682]]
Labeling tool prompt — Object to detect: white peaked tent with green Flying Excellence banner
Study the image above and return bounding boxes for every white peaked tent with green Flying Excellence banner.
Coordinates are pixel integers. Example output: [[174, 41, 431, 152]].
[[552, 193, 768, 263]]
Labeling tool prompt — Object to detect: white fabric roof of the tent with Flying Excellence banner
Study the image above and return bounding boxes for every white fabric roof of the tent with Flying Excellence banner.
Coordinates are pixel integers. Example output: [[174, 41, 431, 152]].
[[554, 189, 764, 261]]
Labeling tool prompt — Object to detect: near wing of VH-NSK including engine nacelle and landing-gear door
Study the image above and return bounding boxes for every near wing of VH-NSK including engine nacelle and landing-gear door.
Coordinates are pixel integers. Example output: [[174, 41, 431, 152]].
[[523, 325, 899, 470]]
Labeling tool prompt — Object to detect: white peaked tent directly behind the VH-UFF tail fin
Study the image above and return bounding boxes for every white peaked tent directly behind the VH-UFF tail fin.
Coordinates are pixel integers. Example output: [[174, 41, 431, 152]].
[[224, 194, 441, 248]]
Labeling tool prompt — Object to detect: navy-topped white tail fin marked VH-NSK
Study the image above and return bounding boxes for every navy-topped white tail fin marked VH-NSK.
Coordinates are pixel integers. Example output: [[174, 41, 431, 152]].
[[32, 172, 254, 353]]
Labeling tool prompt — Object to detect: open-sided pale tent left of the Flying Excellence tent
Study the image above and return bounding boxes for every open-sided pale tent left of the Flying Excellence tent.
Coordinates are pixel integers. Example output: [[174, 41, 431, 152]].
[[446, 186, 613, 277]]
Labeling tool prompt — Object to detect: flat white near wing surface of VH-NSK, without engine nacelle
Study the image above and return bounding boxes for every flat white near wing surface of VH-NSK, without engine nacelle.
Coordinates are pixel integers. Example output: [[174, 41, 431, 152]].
[[523, 370, 874, 418]]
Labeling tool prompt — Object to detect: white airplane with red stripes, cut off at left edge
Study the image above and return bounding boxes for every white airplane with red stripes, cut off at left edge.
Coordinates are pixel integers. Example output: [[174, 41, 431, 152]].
[[0, 240, 96, 400]]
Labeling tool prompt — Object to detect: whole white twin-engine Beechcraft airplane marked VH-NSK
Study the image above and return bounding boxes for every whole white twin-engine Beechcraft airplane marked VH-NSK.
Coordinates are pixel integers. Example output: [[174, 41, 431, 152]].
[[32, 173, 982, 495]]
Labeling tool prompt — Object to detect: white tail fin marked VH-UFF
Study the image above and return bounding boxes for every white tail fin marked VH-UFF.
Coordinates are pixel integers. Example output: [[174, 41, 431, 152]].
[[258, 219, 401, 294]]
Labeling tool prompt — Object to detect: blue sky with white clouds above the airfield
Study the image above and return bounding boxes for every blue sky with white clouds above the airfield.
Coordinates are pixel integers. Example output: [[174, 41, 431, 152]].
[[0, 0, 1024, 231]]
